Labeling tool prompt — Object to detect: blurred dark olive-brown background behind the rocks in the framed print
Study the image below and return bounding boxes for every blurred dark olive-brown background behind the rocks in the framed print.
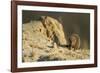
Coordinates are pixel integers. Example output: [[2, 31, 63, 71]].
[[22, 10, 90, 49]]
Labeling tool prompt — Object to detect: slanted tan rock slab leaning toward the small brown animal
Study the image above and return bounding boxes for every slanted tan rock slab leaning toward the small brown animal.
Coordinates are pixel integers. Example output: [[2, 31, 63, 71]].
[[42, 16, 67, 45]]
